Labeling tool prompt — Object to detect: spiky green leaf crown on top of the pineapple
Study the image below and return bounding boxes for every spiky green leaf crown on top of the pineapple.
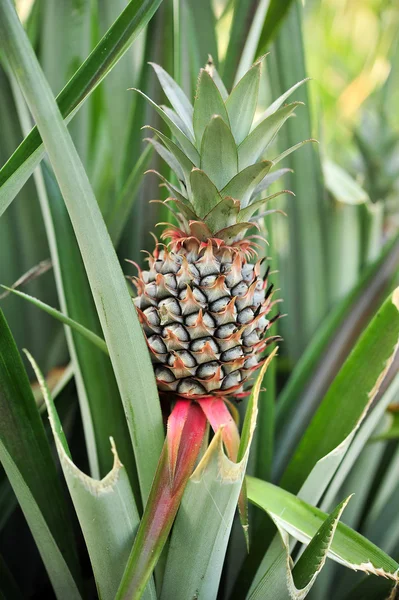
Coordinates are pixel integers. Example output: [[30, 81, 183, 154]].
[[137, 59, 310, 243]]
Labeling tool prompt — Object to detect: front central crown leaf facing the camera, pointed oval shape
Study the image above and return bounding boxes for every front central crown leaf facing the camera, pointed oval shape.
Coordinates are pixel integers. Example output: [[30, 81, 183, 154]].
[[201, 116, 238, 190]]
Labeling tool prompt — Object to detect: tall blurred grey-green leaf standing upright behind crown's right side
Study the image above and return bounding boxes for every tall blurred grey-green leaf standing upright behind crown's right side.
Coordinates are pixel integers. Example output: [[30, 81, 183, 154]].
[[268, 1, 328, 359]]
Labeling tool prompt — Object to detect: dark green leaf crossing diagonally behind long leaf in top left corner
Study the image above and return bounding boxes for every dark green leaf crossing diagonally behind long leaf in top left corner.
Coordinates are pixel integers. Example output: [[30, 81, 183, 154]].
[[0, 0, 166, 216]]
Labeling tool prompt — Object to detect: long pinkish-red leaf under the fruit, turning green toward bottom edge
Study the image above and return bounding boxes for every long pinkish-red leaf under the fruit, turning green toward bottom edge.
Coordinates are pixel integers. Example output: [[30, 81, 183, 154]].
[[116, 400, 206, 600]]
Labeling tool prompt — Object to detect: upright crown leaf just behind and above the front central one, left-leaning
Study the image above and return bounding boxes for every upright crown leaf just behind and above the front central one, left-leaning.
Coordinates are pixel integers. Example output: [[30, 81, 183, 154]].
[[193, 69, 229, 149]]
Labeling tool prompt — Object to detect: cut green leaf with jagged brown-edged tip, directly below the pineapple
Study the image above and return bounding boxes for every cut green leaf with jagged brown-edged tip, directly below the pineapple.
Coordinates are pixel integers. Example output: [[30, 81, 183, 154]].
[[161, 357, 278, 600]]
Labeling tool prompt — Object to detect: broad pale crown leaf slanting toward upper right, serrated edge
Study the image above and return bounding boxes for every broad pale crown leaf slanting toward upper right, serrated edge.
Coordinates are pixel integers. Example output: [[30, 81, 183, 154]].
[[238, 102, 302, 170]]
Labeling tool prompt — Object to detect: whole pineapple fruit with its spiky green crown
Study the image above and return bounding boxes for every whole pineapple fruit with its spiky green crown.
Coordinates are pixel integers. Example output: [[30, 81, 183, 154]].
[[132, 59, 308, 399]]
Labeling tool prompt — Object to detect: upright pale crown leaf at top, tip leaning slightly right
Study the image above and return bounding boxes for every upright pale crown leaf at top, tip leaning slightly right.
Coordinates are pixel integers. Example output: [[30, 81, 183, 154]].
[[226, 62, 261, 144]]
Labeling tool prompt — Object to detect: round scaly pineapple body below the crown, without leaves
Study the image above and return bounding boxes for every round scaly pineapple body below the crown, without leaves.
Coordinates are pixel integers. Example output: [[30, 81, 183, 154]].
[[133, 237, 276, 399]]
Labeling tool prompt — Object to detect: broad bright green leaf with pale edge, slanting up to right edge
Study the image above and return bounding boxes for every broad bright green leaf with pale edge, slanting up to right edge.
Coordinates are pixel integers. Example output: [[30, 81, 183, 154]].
[[282, 288, 399, 502]]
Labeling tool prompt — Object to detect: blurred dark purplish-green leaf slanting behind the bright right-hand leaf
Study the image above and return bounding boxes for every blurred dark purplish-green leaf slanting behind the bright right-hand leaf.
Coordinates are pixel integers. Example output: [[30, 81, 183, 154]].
[[275, 234, 399, 473]]
